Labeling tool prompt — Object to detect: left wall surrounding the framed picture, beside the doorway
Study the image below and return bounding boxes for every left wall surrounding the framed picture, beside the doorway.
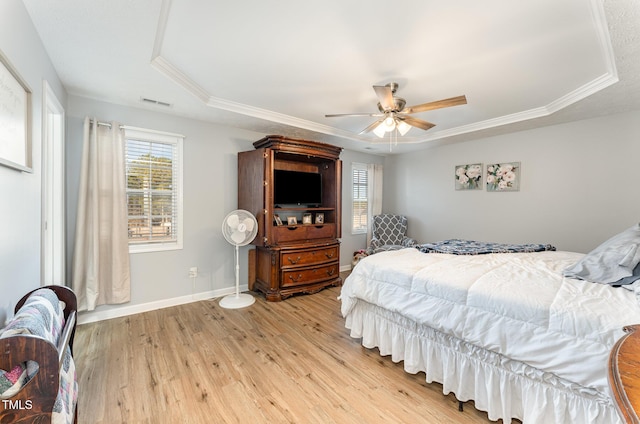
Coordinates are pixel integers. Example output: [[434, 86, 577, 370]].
[[0, 0, 66, 327]]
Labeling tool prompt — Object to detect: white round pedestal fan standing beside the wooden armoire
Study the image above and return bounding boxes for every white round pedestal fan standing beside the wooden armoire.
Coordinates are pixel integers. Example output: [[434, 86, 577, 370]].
[[220, 209, 258, 309]]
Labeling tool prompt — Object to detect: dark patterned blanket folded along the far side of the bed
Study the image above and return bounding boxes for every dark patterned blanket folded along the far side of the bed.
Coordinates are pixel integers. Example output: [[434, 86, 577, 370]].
[[416, 239, 556, 255]]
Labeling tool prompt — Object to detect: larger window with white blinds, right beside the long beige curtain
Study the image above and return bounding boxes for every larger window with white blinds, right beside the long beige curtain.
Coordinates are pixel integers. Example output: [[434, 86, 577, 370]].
[[125, 128, 183, 252]]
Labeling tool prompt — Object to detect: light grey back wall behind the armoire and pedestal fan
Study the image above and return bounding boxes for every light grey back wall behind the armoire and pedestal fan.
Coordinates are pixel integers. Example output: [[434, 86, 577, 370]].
[[66, 96, 382, 320]]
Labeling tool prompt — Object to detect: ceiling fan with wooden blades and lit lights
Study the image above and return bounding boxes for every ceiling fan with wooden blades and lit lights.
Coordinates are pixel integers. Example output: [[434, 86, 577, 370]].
[[325, 82, 467, 138]]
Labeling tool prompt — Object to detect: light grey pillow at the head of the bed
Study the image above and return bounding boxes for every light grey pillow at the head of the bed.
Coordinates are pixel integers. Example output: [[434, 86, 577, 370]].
[[564, 224, 640, 285]]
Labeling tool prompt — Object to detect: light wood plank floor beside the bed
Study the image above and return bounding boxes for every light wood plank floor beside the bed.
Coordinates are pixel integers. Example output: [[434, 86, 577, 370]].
[[74, 280, 502, 424]]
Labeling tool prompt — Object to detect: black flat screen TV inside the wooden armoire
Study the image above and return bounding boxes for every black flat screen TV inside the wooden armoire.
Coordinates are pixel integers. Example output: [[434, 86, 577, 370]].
[[273, 169, 322, 206]]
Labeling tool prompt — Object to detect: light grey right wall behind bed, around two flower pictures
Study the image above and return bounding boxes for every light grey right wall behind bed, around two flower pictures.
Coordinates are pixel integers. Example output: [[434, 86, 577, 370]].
[[384, 112, 640, 252]]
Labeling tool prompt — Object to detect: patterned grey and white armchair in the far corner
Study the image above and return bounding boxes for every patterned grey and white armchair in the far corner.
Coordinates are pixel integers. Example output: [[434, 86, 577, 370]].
[[367, 214, 417, 255]]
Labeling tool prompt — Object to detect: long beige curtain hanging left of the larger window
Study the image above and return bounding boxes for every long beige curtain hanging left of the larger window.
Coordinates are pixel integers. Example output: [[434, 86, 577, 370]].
[[72, 117, 131, 311]]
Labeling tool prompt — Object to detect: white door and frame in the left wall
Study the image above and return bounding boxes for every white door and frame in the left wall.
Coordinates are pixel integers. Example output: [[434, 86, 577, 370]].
[[42, 81, 66, 285]]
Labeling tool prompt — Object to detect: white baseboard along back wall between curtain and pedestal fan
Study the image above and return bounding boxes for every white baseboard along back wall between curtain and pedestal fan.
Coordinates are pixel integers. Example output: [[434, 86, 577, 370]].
[[78, 285, 248, 325]]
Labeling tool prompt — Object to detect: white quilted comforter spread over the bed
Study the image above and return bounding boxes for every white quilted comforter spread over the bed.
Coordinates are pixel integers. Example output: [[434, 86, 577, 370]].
[[341, 249, 640, 393]]
